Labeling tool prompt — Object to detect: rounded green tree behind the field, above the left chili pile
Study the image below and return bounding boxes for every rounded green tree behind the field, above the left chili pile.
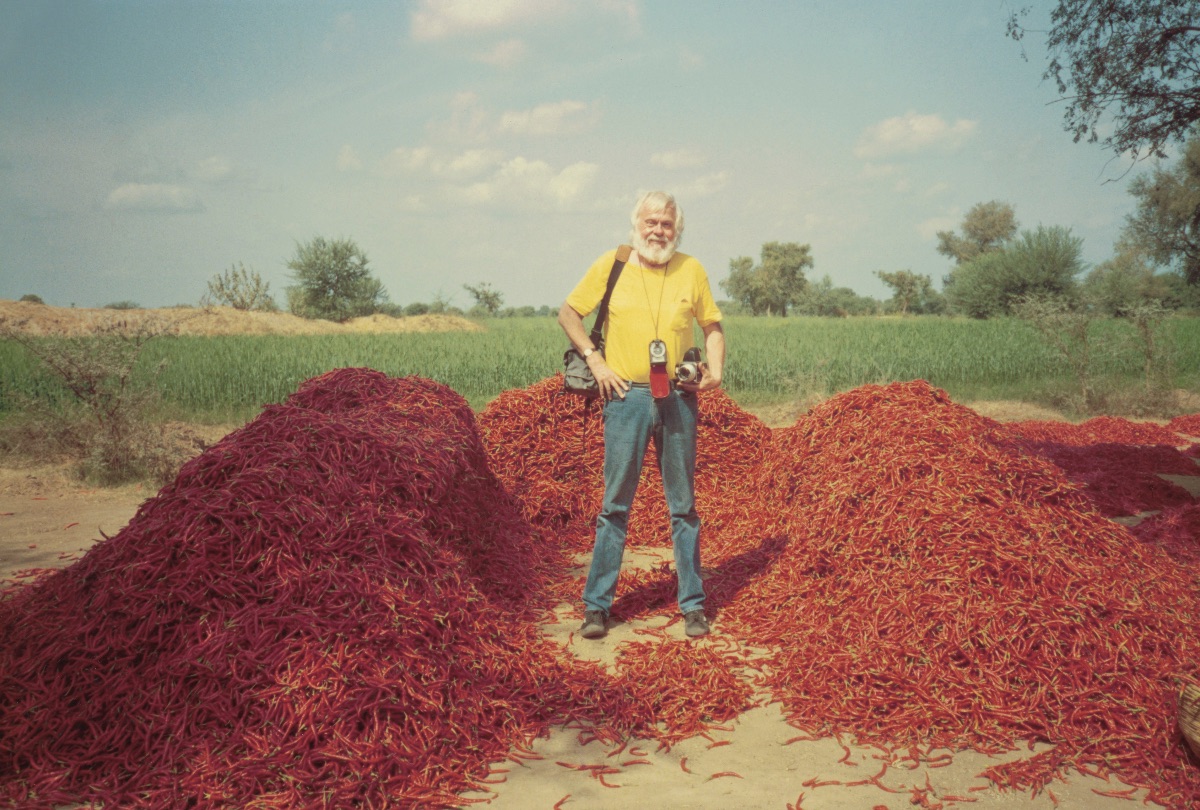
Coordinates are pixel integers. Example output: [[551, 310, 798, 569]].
[[287, 236, 388, 323]]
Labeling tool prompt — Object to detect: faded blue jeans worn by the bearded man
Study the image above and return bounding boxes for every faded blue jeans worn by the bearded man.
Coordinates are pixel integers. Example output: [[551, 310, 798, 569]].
[[583, 385, 704, 616]]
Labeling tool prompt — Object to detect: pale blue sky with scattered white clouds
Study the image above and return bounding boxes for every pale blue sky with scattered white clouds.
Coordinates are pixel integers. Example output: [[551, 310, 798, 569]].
[[0, 0, 1147, 308]]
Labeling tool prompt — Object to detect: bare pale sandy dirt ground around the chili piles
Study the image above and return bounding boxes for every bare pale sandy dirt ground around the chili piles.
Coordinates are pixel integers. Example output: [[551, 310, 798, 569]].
[[0, 403, 1185, 810]]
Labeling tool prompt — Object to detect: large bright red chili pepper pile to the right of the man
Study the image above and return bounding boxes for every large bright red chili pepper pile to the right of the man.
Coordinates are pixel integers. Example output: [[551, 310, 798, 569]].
[[725, 382, 1200, 805]]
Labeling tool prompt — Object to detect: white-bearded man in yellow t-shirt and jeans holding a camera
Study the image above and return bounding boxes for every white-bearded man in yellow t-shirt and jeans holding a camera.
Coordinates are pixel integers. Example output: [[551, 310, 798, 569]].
[[558, 191, 725, 638]]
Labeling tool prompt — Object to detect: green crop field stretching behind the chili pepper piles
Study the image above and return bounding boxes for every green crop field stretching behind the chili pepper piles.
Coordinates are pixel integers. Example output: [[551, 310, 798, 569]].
[[0, 317, 1200, 422]]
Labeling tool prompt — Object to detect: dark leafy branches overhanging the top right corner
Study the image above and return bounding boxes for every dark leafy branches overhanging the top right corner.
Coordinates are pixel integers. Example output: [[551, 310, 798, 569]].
[[1008, 0, 1200, 157]]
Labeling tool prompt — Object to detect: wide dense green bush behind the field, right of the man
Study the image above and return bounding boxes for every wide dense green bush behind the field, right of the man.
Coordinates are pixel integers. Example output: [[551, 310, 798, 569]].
[[946, 226, 1084, 318]]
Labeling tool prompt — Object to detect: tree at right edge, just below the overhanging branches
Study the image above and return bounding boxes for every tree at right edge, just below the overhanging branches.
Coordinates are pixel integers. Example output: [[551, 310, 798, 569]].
[[1122, 137, 1200, 284]]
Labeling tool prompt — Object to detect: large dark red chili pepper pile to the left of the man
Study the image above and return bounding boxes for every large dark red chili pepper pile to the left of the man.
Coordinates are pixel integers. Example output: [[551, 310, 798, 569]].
[[0, 370, 614, 809]]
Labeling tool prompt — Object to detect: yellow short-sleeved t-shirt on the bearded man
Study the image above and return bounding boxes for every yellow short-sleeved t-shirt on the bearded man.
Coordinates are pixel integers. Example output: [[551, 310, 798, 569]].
[[566, 250, 721, 383]]
